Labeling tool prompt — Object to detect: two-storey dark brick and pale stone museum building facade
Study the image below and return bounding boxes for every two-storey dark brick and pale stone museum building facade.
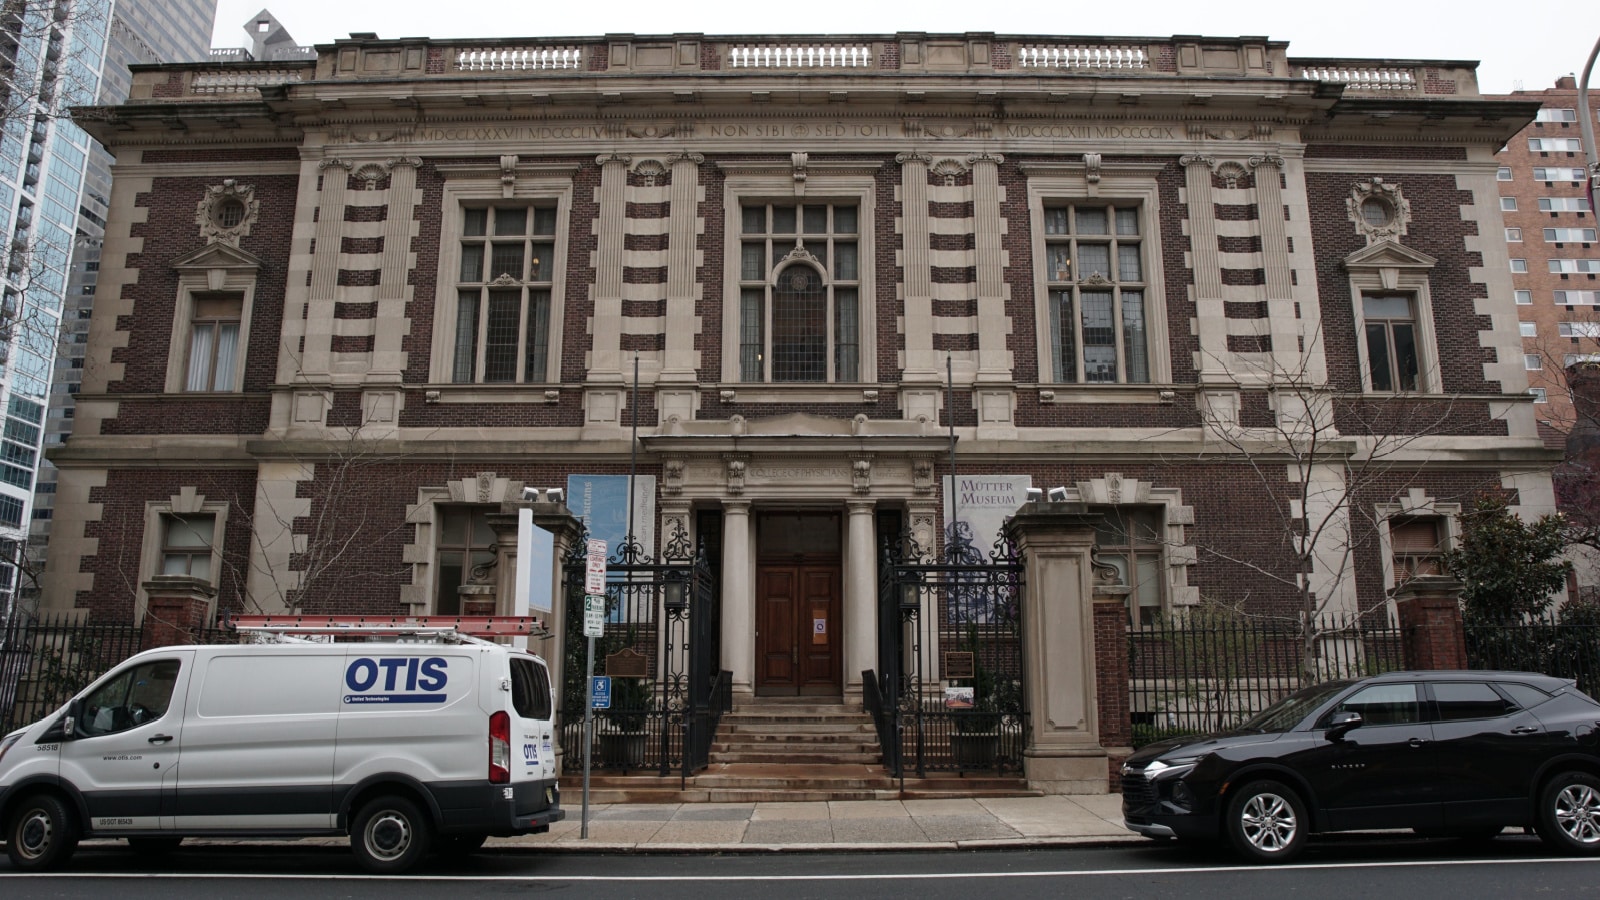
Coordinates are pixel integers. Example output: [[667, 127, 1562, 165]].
[[45, 34, 1554, 714]]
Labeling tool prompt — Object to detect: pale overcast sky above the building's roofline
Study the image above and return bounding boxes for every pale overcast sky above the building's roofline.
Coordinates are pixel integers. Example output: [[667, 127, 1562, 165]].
[[211, 0, 1600, 93]]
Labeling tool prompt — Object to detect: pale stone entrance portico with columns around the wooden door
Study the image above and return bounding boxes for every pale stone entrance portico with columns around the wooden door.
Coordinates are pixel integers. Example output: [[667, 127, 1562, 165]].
[[642, 413, 949, 705]]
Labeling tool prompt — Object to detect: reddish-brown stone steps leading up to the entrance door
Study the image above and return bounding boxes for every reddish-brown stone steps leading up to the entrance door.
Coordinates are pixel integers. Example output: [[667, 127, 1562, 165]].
[[562, 697, 1040, 804]]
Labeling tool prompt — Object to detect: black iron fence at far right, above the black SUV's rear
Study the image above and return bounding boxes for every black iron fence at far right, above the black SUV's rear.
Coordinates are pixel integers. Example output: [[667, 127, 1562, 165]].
[[1466, 617, 1600, 697]]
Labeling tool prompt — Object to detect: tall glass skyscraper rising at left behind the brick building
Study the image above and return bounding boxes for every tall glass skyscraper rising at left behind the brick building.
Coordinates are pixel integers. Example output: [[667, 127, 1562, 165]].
[[0, 0, 216, 615]]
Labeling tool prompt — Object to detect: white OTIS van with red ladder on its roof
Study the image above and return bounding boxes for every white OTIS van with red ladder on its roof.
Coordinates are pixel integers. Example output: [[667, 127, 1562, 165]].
[[0, 620, 565, 873]]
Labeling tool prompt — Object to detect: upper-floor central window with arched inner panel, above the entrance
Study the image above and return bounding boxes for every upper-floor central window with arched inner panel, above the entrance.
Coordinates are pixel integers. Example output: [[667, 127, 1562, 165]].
[[739, 200, 862, 383]]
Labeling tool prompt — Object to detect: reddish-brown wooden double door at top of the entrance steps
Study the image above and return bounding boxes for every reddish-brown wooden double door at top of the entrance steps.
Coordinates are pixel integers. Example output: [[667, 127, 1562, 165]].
[[755, 559, 843, 697]]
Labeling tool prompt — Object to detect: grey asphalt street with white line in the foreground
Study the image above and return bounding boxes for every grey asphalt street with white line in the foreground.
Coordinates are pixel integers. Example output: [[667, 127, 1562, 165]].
[[0, 834, 1600, 900]]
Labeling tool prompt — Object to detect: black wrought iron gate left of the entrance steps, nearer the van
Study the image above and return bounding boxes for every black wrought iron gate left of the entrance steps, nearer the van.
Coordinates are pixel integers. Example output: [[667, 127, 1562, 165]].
[[560, 525, 733, 778]]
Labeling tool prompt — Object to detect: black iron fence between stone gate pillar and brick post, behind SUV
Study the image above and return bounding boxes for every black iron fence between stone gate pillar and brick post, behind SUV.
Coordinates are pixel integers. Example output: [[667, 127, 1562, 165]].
[[1128, 609, 1405, 748]]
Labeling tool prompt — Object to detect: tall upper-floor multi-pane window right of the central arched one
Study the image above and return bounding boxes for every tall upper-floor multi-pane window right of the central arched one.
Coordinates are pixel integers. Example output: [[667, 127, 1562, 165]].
[[1045, 202, 1150, 384]]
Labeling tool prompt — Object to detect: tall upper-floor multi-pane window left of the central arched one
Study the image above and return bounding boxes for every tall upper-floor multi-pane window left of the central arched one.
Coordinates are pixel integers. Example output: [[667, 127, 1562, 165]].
[[451, 205, 557, 384]]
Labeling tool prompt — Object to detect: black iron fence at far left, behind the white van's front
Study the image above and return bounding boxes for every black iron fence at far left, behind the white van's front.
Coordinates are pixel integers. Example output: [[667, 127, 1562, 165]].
[[0, 612, 238, 733]]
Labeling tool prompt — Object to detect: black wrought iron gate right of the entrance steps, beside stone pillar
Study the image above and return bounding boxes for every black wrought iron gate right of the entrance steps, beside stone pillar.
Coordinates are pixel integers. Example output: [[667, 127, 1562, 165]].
[[864, 532, 1029, 777]]
